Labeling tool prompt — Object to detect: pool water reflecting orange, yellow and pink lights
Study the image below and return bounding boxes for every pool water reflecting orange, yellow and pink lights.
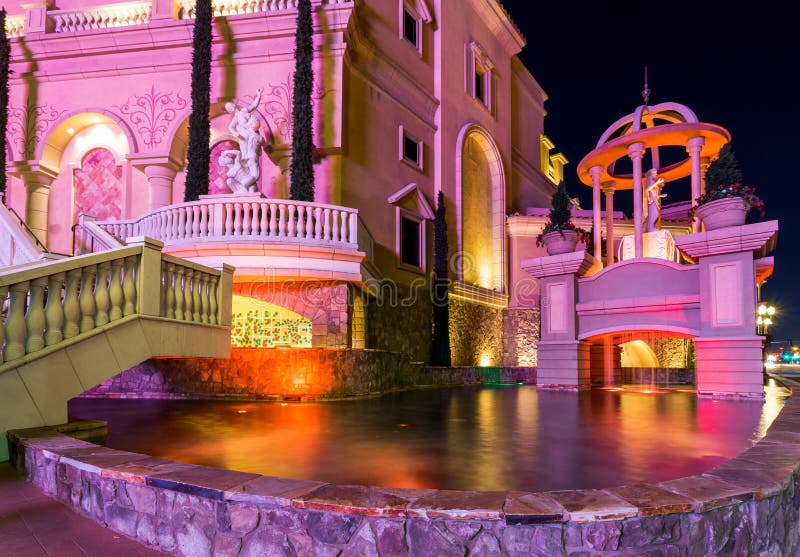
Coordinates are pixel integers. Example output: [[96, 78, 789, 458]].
[[70, 386, 783, 490]]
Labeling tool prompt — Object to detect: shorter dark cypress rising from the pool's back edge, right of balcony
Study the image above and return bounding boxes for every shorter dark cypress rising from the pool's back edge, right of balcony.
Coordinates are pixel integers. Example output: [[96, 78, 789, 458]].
[[431, 191, 450, 366]]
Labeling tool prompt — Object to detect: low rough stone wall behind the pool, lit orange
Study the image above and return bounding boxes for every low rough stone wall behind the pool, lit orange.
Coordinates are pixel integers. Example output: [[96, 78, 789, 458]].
[[83, 348, 536, 399]]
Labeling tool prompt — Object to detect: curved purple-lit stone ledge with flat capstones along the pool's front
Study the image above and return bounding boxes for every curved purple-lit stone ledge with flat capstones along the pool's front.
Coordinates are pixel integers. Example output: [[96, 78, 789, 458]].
[[10, 382, 800, 556]]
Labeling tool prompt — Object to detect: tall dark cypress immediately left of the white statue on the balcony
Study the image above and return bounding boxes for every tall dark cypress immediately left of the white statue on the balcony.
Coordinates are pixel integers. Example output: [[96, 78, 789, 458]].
[[183, 0, 212, 201]]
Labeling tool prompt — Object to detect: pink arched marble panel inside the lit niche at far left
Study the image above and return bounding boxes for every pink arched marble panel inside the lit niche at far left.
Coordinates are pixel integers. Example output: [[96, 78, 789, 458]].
[[72, 148, 122, 223]]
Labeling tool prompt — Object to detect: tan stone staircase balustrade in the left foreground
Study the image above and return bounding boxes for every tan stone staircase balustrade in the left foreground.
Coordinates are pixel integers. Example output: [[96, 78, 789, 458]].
[[0, 238, 233, 366]]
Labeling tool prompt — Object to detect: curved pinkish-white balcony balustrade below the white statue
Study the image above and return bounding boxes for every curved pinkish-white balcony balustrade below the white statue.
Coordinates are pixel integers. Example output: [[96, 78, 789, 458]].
[[90, 196, 358, 249]]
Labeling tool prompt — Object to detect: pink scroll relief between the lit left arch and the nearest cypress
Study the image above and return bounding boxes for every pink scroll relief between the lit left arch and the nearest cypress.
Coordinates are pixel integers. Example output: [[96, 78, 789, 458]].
[[117, 85, 188, 149]]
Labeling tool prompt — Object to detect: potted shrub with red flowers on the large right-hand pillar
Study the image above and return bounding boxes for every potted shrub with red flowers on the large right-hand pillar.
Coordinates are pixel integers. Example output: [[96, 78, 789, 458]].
[[689, 143, 764, 230]]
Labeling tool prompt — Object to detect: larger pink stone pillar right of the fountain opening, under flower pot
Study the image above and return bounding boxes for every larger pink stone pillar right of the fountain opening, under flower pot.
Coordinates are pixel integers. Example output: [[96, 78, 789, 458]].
[[675, 221, 778, 396]]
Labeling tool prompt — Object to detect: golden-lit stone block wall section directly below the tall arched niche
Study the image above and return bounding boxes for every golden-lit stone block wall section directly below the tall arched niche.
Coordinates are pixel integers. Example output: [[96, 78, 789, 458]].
[[450, 297, 504, 366]]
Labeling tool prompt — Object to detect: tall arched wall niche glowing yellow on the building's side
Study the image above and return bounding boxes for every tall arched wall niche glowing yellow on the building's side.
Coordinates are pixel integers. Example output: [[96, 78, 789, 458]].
[[456, 124, 506, 292]]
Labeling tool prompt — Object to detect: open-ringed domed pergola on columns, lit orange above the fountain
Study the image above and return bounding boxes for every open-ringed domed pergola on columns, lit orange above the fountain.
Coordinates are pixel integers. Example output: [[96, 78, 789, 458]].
[[578, 101, 731, 264]]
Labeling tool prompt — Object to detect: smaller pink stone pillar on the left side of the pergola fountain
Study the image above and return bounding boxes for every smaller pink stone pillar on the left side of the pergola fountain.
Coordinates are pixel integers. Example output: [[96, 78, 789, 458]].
[[522, 251, 601, 390]]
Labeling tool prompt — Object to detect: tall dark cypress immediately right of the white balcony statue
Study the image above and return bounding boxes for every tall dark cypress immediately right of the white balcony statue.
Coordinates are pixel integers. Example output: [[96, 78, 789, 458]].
[[289, 0, 314, 201]]
